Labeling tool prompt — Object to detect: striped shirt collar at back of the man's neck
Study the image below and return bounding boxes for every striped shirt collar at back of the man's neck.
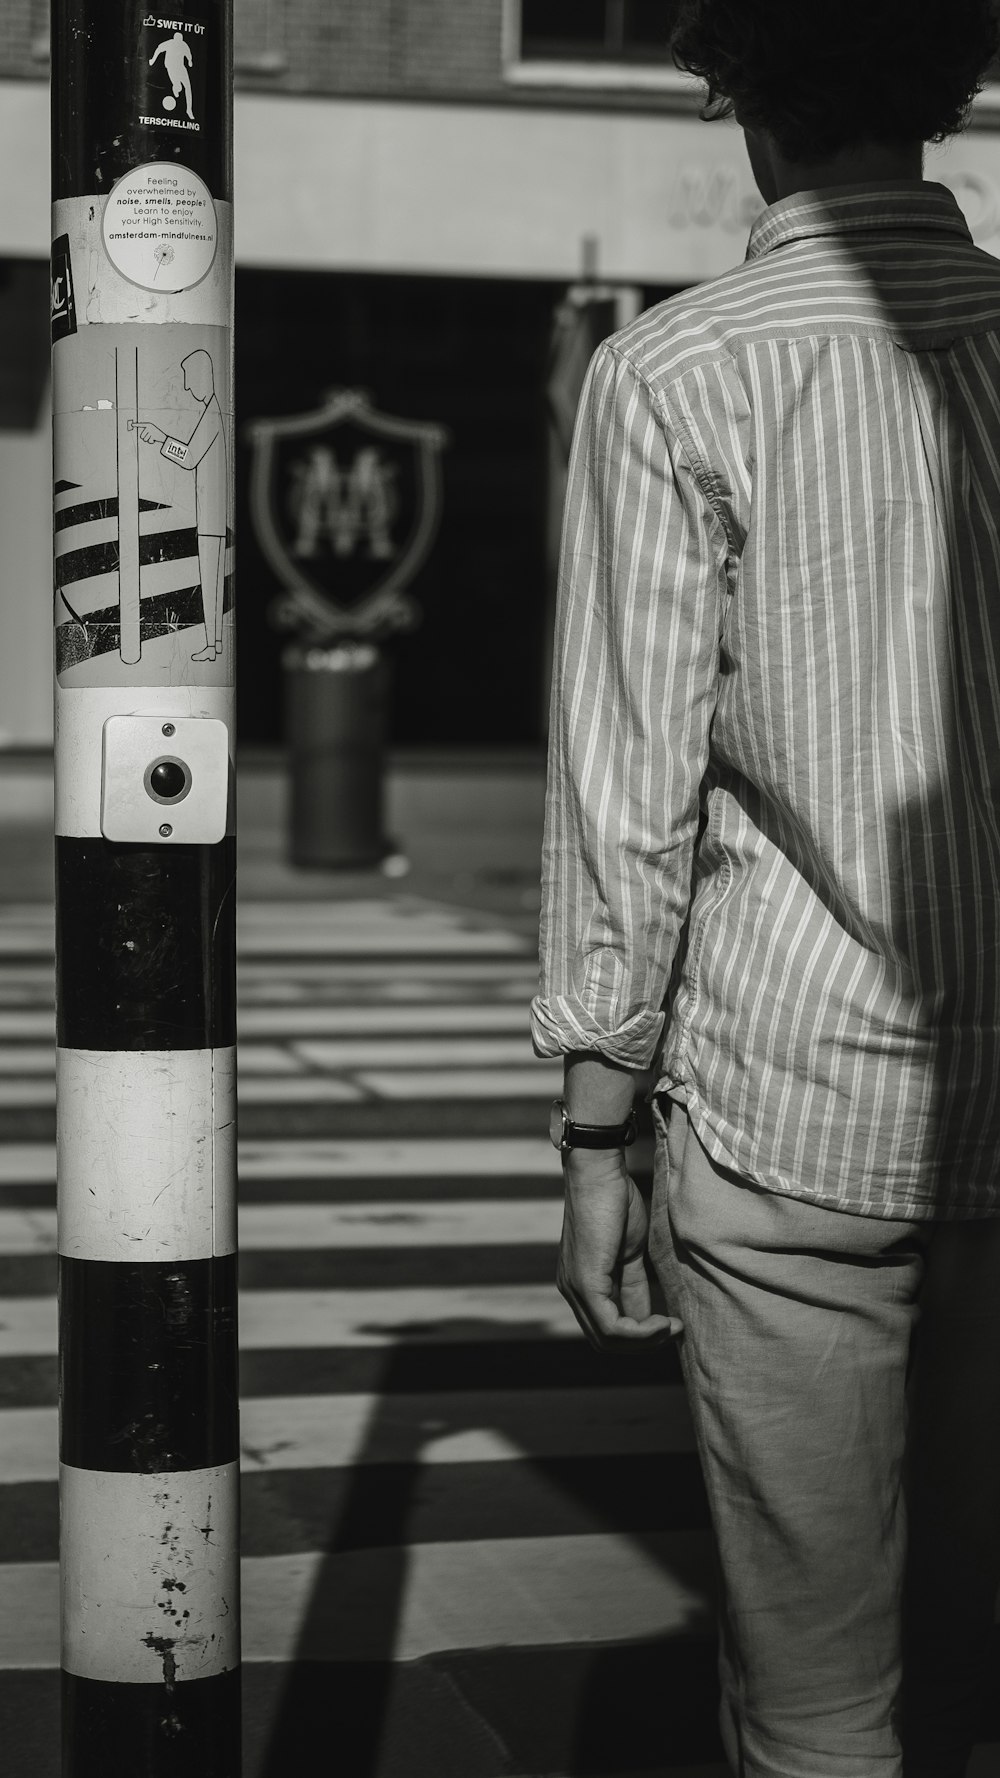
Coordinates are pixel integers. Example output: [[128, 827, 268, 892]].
[[747, 180, 972, 260]]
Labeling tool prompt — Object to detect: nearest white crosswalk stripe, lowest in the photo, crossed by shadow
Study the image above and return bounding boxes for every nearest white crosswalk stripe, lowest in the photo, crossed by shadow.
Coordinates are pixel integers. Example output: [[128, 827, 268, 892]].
[[0, 1529, 712, 1668]]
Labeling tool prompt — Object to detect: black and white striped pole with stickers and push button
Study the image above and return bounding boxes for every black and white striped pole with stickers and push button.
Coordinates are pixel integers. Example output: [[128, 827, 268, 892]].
[[52, 0, 240, 1778]]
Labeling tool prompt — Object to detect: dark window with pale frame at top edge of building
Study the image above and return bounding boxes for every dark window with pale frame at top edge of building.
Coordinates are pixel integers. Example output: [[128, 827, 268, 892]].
[[521, 0, 680, 66]]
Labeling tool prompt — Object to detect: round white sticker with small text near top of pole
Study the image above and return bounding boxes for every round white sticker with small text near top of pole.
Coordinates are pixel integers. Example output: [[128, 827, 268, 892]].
[[101, 160, 219, 290]]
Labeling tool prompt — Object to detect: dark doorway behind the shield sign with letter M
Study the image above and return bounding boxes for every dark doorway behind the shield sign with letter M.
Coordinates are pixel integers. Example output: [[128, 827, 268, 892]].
[[237, 268, 562, 745]]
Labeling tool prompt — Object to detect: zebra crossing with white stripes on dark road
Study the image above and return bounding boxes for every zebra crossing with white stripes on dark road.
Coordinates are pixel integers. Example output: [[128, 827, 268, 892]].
[[0, 898, 1000, 1778]]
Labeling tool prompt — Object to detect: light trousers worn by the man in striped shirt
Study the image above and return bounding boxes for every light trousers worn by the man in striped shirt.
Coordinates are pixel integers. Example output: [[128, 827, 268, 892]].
[[649, 1099, 1000, 1778]]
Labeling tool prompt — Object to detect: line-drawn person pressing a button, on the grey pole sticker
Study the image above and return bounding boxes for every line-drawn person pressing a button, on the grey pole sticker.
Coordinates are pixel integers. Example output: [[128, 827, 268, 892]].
[[139, 347, 230, 661]]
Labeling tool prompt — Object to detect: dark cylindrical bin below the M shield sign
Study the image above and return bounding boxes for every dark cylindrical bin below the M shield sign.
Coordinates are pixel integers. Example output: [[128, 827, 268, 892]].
[[283, 642, 393, 869]]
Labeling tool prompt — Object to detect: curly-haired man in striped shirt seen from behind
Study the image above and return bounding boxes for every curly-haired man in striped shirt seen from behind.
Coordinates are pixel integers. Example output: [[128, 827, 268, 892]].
[[532, 0, 1000, 1778]]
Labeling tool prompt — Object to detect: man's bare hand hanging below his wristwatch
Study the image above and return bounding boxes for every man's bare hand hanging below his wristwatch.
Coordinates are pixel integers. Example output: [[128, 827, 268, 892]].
[[555, 1149, 683, 1351]]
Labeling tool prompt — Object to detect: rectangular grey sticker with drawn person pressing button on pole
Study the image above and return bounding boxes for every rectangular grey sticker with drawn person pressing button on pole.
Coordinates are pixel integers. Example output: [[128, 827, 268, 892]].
[[53, 324, 235, 688]]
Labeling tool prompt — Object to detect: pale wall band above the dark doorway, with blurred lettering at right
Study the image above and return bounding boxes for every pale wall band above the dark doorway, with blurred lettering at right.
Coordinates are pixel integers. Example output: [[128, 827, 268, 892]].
[[0, 80, 1000, 284]]
